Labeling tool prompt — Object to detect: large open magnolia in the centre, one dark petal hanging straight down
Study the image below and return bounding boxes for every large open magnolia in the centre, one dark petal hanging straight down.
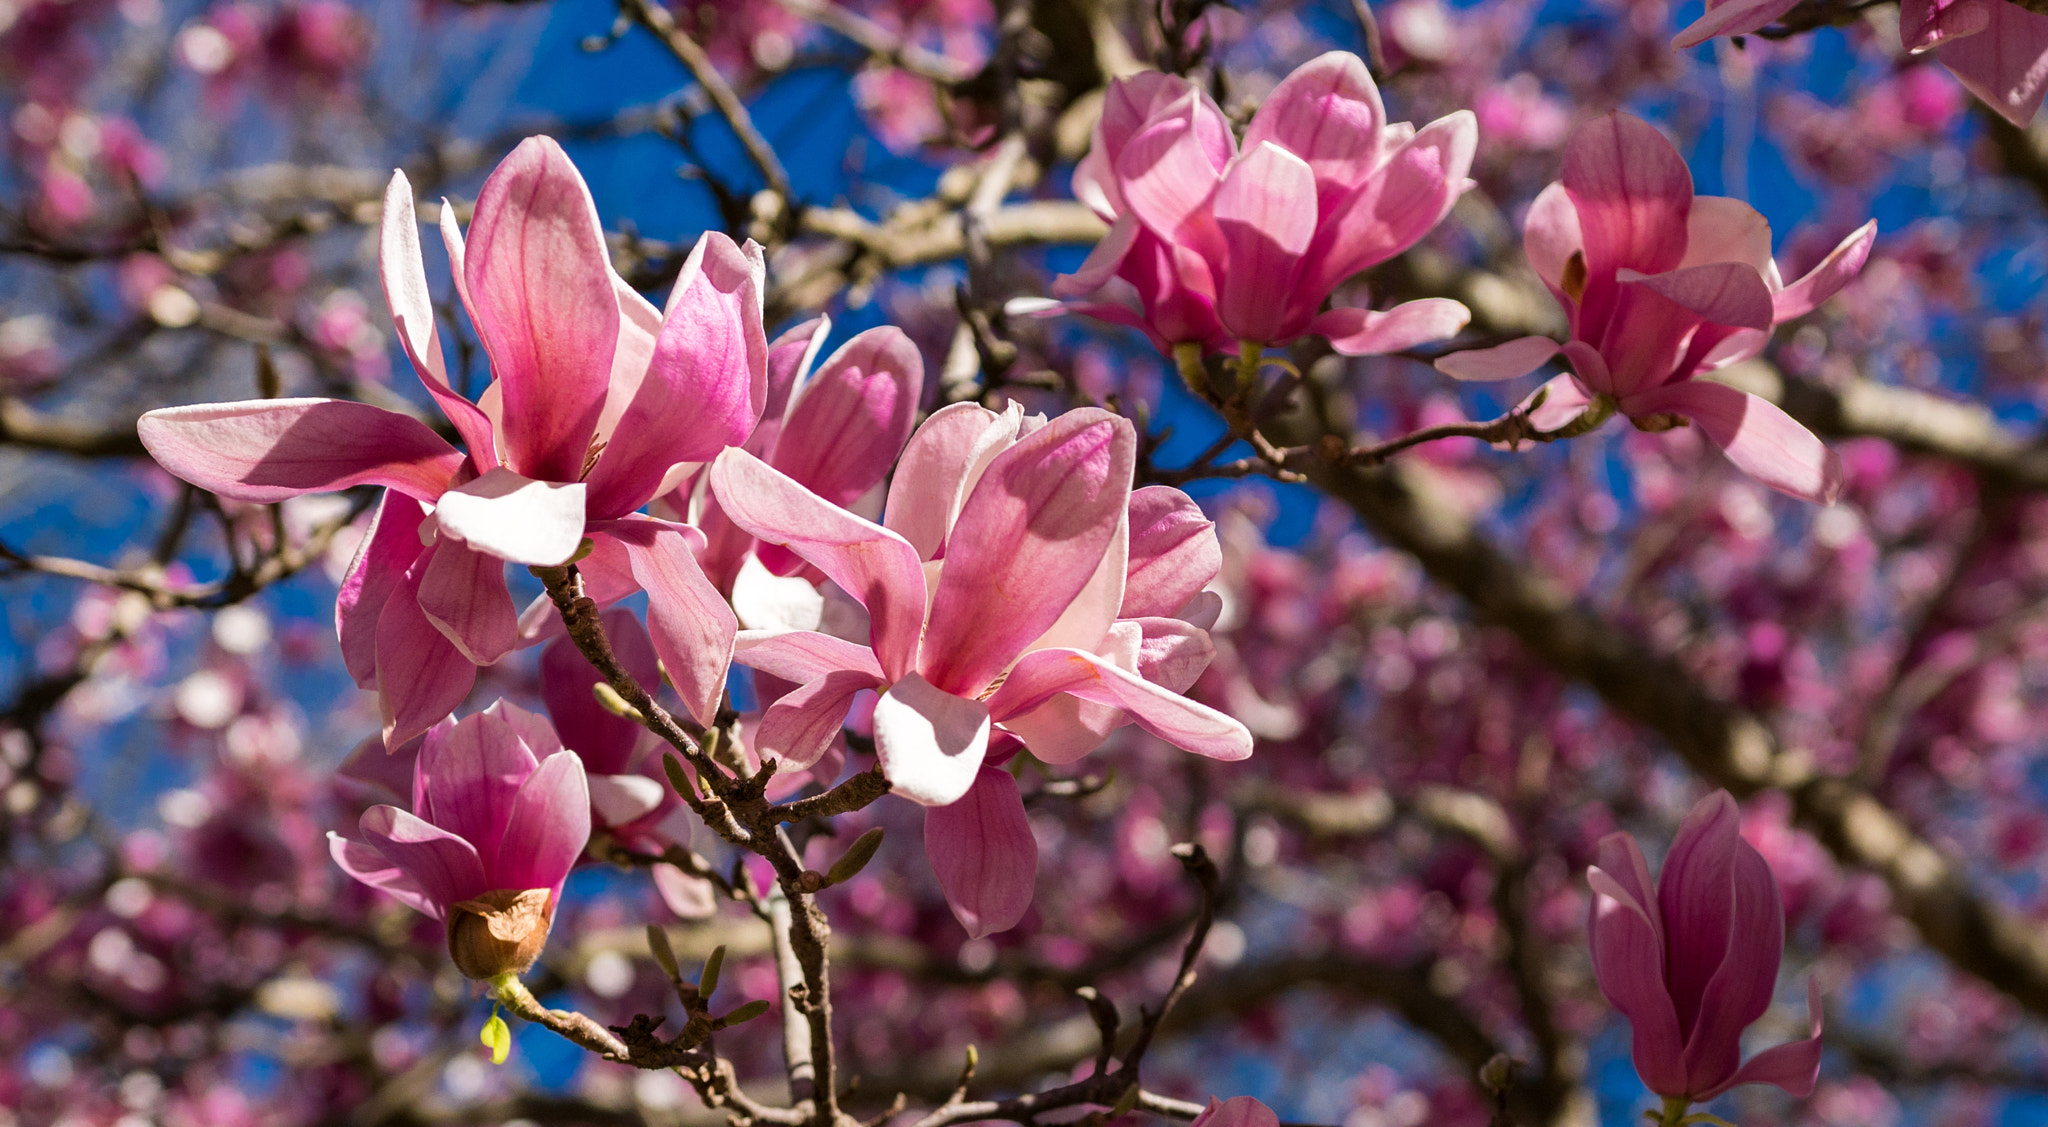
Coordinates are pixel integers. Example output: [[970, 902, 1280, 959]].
[[711, 404, 1251, 934]]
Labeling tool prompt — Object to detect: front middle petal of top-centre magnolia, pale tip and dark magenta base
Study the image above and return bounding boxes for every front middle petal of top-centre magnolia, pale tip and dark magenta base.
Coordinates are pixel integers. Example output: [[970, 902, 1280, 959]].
[[1212, 141, 1321, 342]]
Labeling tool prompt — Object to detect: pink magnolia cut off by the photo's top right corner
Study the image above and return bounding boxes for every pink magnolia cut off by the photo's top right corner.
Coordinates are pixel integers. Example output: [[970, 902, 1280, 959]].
[[1671, 0, 2048, 127]]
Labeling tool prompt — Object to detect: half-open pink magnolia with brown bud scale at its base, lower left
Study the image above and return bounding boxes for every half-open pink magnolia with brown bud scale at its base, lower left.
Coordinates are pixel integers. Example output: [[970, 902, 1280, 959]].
[[328, 701, 590, 979]]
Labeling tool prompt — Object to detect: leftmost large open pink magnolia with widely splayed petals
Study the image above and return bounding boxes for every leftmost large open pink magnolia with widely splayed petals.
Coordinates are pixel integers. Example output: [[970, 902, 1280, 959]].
[[139, 137, 768, 746]]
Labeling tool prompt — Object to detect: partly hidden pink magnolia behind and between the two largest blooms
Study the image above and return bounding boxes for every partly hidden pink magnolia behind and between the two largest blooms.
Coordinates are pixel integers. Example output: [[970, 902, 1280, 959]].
[[679, 318, 924, 594]]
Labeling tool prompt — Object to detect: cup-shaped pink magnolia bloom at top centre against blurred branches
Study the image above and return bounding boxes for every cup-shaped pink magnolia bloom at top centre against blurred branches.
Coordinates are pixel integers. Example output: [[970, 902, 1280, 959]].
[[1055, 51, 1479, 357]]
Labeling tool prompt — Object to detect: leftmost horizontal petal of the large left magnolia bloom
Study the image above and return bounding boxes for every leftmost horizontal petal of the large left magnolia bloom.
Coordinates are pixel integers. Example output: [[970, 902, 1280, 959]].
[[135, 400, 463, 504]]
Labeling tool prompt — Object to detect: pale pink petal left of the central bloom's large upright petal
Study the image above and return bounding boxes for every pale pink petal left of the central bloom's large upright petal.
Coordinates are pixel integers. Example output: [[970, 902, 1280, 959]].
[[883, 404, 1024, 559]]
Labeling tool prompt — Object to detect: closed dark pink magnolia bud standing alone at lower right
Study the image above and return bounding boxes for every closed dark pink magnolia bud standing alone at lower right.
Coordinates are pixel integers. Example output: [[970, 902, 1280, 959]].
[[1587, 791, 1821, 1102]]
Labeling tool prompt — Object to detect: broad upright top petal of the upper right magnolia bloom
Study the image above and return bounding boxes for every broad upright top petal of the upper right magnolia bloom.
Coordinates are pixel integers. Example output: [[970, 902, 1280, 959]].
[[1563, 113, 1692, 277]]
